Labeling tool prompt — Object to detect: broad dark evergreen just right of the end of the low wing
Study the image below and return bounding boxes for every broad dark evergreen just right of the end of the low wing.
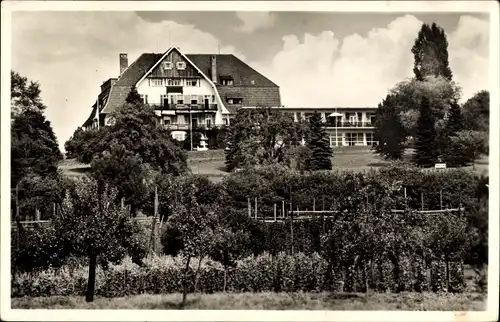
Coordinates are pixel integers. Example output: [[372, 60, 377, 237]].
[[373, 95, 407, 160]]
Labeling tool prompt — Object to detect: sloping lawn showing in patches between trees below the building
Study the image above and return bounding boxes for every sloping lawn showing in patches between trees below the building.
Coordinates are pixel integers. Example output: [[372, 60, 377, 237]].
[[59, 147, 488, 182]]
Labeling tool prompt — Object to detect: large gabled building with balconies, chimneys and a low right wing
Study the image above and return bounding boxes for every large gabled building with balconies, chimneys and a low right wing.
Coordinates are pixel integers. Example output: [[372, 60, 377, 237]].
[[83, 47, 376, 149]]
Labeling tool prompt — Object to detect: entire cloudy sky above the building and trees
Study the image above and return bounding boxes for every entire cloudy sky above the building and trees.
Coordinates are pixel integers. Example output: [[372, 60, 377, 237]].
[[11, 11, 489, 150]]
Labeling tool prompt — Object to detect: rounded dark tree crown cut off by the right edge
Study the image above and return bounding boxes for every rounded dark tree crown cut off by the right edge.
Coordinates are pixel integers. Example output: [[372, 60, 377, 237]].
[[462, 90, 490, 134]]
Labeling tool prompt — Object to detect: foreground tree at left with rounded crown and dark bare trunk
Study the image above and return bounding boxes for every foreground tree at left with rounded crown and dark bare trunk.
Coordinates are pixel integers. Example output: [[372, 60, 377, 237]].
[[53, 177, 142, 302]]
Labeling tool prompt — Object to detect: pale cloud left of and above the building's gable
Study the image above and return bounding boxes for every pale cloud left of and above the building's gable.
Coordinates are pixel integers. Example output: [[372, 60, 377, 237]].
[[12, 12, 244, 148]]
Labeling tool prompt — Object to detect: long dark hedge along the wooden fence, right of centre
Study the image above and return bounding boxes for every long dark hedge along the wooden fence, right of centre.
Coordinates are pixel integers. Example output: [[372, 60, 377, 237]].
[[223, 166, 487, 216]]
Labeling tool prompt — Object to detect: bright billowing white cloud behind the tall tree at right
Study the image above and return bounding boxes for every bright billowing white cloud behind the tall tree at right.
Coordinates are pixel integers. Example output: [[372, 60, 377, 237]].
[[251, 15, 488, 107]]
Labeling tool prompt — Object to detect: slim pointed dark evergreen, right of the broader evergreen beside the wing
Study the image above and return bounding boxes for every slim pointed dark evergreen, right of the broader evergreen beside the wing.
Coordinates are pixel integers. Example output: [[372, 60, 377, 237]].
[[414, 97, 439, 167]]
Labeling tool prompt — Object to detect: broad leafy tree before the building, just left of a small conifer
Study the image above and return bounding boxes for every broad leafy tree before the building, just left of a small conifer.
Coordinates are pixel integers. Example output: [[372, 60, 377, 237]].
[[226, 108, 302, 171]]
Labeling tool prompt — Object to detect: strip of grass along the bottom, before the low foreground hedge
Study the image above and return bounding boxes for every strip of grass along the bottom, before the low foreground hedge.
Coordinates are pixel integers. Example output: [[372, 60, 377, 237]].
[[12, 293, 486, 311]]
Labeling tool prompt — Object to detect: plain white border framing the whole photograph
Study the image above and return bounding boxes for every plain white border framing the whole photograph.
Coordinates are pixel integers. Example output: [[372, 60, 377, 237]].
[[0, 1, 500, 321]]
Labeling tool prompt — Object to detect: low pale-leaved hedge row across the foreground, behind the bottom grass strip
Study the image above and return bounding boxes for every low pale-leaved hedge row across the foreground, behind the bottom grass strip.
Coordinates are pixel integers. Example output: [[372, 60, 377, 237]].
[[11, 253, 464, 297]]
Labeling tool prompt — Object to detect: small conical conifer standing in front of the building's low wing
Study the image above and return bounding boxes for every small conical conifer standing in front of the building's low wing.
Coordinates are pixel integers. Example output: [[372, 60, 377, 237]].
[[307, 112, 333, 171]]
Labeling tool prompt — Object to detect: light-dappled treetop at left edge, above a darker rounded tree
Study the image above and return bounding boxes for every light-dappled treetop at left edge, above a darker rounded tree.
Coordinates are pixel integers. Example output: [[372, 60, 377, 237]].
[[10, 70, 46, 118]]
